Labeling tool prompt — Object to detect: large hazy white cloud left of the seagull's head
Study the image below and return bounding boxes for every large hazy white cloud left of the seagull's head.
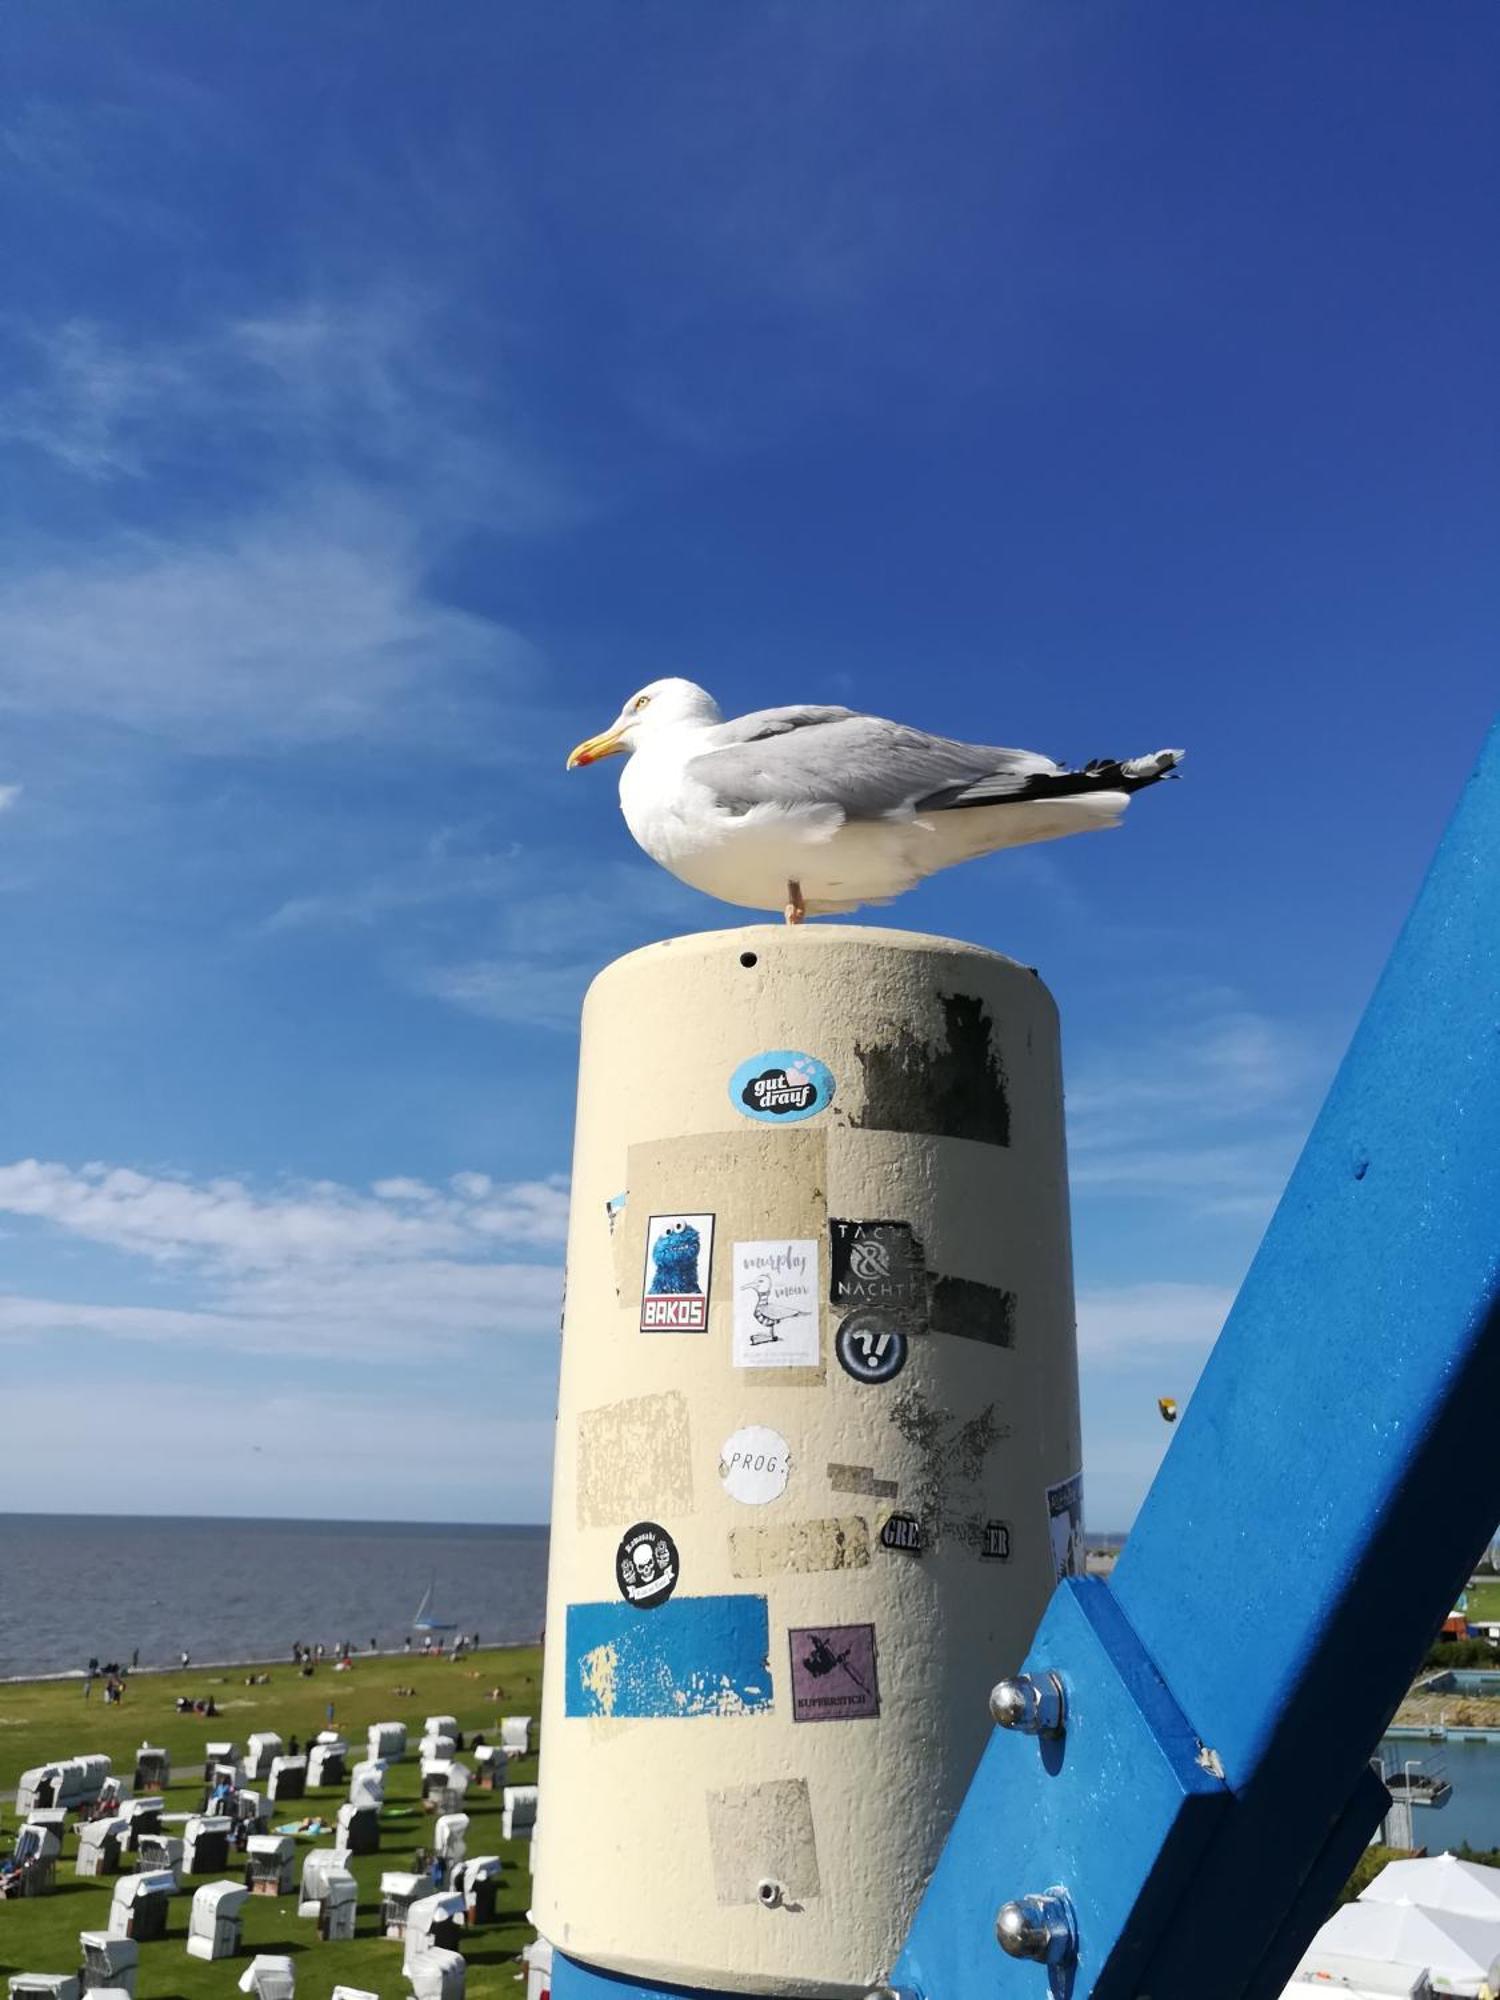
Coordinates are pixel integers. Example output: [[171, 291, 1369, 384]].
[[0, 490, 538, 752]]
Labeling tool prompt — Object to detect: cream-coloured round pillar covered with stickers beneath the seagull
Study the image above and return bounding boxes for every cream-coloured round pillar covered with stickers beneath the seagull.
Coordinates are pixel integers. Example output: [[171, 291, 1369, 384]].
[[532, 924, 1082, 1994]]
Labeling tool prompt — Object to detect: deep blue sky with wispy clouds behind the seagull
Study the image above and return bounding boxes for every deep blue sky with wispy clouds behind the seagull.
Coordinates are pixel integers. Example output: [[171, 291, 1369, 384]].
[[0, 0, 1500, 1528]]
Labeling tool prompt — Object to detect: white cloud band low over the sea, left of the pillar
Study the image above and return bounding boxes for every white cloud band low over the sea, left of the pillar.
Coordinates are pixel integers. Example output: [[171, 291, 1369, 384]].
[[0, 1160, 568, 1360]]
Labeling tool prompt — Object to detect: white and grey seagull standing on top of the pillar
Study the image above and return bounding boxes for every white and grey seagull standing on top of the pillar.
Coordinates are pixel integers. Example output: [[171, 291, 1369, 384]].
[[568, 680, 1184, 924]]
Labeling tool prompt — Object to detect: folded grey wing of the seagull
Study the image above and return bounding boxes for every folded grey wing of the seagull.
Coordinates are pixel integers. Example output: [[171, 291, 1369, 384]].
[[688, 708, 1060, 820]]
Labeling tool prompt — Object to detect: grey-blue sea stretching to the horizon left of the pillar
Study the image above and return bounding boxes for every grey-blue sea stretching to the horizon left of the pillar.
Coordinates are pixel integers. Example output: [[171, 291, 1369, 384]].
[[0, 1514, 548, 1676]]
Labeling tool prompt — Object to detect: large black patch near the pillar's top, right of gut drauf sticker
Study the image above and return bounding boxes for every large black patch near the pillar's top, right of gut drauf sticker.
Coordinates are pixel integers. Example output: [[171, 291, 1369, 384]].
[[850, 994, 1010, 1146]]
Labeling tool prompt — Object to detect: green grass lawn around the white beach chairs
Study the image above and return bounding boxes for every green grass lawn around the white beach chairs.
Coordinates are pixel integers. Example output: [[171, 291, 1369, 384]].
[[0, 1646, 540, 2000]]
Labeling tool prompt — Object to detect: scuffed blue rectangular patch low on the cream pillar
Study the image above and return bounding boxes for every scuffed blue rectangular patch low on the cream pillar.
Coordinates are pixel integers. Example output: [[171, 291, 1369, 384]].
[[566, 1596, 772, 1718]]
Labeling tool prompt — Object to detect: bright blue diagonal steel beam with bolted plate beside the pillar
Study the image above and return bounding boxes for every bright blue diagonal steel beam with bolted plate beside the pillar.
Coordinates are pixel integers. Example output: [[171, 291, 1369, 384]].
[[554, 728, 1500, 2000]]
